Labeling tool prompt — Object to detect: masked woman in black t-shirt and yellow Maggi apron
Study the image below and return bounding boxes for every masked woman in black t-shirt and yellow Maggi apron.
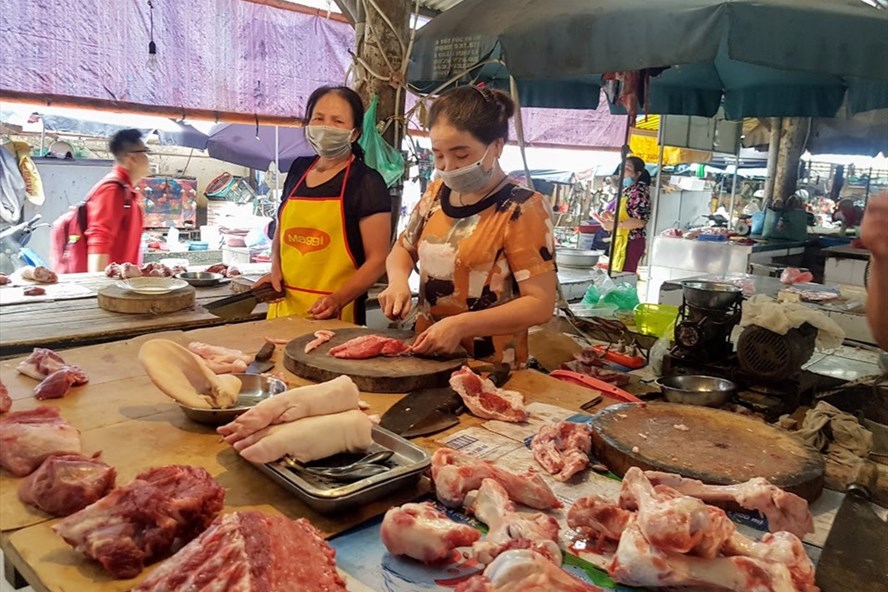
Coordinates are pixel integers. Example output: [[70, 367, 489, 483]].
[[257, 87, 391, 324]]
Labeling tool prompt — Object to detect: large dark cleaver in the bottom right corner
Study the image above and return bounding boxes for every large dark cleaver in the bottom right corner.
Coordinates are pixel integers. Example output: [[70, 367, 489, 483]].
[[816, 461, 888, 592]]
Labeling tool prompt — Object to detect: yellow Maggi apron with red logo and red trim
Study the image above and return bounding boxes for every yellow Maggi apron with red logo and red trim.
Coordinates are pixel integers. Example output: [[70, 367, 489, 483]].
[[268, 160, 358, 323]]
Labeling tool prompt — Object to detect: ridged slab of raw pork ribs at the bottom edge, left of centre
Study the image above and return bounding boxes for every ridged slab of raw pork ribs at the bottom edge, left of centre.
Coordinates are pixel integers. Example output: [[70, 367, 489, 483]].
[[133, 512, 346, 592]]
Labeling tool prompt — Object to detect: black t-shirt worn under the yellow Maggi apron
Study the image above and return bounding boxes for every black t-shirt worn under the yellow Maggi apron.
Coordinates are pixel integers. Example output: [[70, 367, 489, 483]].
[[278, 156, 392, 265]]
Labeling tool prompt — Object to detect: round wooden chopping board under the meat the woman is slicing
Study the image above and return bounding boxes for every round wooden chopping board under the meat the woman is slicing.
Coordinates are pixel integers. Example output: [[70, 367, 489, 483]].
[[284, 328, 466, 393]]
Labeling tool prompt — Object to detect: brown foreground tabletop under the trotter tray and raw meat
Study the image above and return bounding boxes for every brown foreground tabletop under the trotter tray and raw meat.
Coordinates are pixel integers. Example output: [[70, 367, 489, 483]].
[[0, 318, 601, 592]]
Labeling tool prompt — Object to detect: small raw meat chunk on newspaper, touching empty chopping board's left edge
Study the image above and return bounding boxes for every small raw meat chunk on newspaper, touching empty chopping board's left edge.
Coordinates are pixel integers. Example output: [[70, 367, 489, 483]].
[[530, 421, 592, 481]]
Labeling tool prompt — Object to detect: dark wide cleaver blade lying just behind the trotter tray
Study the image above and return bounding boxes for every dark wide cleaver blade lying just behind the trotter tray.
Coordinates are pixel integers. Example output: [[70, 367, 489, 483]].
[[380, 387, 462, 437]]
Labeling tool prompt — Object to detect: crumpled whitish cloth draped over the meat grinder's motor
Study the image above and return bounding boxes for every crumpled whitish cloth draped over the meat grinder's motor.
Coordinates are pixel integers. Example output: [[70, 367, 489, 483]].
[[740, 294, 845, 350]]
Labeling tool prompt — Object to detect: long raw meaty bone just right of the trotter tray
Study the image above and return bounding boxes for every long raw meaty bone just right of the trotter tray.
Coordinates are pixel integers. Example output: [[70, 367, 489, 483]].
[[432, 448, 561, 510]]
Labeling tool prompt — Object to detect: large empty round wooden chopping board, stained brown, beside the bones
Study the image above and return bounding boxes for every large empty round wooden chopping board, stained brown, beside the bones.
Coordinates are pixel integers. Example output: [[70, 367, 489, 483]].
[[592, 403, 824, 501]]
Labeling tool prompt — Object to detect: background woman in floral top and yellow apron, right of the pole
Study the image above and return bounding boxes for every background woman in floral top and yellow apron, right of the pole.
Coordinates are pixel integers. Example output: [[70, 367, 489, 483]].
[[601, 156, 651, 273]]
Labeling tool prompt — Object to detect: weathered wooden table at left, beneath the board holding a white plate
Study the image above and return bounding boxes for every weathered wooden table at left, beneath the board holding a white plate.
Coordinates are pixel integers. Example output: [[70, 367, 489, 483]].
[[0, 273, 268, 359]]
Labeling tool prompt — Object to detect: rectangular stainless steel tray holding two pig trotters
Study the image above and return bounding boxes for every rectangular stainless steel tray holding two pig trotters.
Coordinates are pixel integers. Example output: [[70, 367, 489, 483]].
[[256, 426, 431, 512]]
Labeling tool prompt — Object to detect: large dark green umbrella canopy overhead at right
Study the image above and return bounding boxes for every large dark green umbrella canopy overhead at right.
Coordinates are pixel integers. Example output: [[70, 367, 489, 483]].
[[409, 0, 888, 119]]
